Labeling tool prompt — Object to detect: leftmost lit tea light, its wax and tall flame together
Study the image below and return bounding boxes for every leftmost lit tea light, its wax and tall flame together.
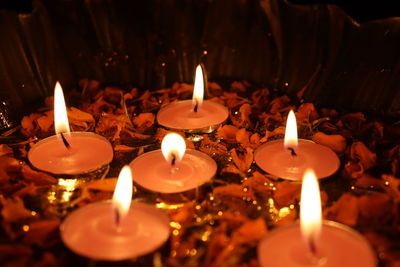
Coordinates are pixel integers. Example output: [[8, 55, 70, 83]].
[[28, 82, 114, 175]]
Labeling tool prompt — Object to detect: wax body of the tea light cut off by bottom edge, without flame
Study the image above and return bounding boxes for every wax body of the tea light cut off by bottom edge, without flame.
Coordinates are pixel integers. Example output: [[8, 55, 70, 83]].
[[258, 221, 377, 267]]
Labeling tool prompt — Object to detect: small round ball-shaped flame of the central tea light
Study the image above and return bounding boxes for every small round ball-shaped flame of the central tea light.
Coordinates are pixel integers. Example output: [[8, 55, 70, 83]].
[[161, 133, 186, 165]]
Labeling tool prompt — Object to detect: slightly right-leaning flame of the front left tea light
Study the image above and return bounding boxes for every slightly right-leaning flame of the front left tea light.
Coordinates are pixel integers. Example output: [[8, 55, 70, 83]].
[[112, 165, 132, 224]]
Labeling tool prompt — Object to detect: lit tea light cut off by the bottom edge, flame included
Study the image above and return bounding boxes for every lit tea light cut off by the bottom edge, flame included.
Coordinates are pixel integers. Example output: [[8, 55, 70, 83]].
[[258, 170, 377, 267]]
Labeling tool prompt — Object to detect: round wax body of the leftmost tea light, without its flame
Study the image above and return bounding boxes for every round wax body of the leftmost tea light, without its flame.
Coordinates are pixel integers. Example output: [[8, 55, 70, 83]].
[[28, 132, 114, 175]]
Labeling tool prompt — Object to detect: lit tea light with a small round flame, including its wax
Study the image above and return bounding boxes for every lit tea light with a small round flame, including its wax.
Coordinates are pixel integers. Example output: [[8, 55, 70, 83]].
[[130, 133, 217, 193]]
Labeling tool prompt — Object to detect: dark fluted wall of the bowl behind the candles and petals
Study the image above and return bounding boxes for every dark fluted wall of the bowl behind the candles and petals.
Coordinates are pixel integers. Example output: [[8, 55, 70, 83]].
[[0, 0, 400, 125]]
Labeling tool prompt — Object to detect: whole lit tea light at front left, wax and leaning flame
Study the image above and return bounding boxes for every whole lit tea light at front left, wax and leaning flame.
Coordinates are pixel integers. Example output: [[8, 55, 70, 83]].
[[60, 166, 170, 261]]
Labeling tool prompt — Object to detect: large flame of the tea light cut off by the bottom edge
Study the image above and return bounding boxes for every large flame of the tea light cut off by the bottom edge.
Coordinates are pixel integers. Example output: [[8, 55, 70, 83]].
[[300, 169, 322, 252]]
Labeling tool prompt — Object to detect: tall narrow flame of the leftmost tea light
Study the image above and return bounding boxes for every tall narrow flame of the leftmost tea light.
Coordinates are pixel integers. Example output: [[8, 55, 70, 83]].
[[54, 82, 70, 134]]
